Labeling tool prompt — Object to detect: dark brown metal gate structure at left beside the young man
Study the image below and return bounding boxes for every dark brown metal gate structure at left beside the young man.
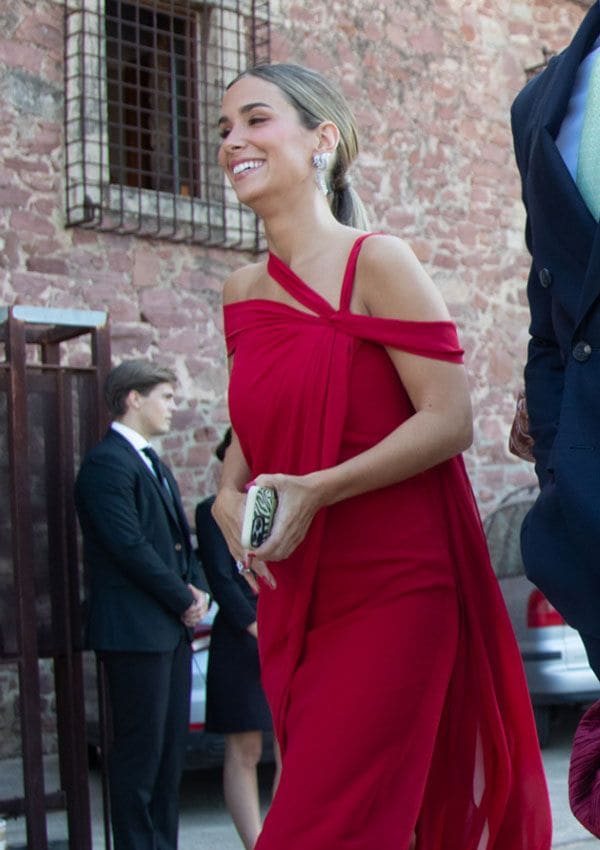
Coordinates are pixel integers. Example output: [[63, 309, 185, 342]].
[[0, 306, 110, 850]]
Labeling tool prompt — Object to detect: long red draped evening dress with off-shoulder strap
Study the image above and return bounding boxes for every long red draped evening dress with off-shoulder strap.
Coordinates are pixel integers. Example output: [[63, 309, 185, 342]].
[[225, 237, 551, 850]]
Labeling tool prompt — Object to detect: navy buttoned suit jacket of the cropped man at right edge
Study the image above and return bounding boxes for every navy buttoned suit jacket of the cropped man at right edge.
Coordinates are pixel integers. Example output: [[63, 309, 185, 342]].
[[512, 3, 600, 637]]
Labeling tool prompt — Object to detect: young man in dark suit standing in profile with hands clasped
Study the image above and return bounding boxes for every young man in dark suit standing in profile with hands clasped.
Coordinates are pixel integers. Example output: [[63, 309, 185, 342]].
[[75, 360, 209, 850]]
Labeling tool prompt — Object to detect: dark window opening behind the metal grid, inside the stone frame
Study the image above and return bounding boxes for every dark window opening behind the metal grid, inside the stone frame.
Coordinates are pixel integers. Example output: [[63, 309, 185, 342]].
[[106, 0, 202, 197]]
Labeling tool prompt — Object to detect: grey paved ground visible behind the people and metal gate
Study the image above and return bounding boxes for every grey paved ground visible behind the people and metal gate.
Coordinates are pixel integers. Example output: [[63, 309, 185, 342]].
[[0, 711, 599, 850]]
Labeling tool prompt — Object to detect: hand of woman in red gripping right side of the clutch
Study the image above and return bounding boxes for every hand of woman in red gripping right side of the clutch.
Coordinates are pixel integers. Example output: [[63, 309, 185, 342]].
[[249, 473, 324, 564]]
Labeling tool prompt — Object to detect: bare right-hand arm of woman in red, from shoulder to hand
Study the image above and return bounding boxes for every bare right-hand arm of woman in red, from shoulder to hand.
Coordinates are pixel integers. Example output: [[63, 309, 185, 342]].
[[250, 236, 472, 561]]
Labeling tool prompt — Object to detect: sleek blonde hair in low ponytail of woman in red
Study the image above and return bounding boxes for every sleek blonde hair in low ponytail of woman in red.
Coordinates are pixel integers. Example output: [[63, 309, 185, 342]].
[[228, 62, 369, 230]]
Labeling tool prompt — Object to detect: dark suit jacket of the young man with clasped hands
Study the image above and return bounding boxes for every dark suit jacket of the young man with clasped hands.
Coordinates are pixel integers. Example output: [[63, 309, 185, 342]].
[[75, 428, 207, 652]]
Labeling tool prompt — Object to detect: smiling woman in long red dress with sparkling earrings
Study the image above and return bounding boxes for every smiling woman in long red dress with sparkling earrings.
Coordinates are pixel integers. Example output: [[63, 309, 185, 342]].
[[213, 65, 550, 850]]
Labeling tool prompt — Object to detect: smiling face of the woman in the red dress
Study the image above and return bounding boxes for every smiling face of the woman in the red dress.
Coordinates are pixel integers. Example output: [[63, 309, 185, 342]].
[[219, 76, 318, 206]]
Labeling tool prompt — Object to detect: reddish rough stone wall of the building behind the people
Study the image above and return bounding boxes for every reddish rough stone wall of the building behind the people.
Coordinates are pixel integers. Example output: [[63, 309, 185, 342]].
[[0, 0, 589, 513]]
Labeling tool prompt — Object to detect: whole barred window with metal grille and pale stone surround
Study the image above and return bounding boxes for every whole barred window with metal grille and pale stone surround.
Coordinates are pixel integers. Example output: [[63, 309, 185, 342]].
[[65, 0, 270, 250]]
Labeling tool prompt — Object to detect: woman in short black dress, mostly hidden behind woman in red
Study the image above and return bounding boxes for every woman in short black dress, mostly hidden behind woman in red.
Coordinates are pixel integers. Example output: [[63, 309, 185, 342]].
[[196, 431, 279, 850]]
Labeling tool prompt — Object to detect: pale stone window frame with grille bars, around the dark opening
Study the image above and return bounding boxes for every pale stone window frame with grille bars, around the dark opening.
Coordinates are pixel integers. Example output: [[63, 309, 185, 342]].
[[64, 0, 270, 251]]
